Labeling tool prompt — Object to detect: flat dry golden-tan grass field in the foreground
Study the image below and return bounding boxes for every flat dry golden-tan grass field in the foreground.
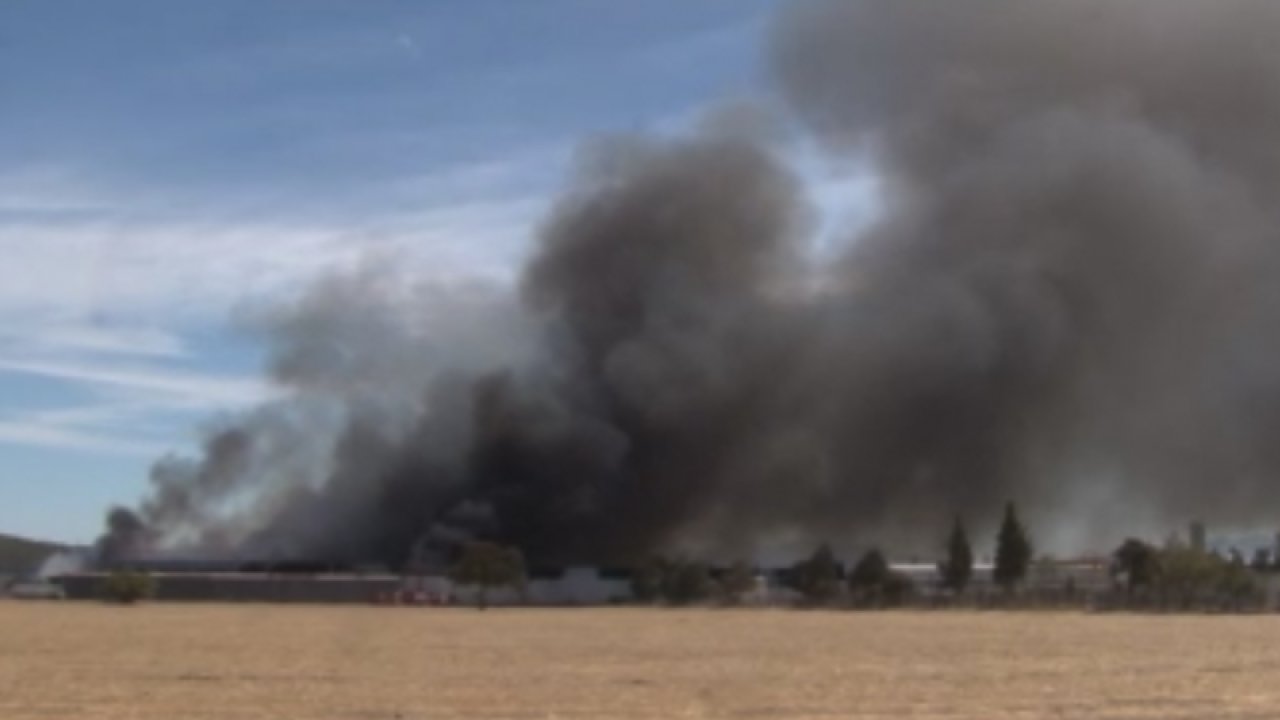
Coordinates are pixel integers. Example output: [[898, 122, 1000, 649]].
[[0, 602, 1280, 720]]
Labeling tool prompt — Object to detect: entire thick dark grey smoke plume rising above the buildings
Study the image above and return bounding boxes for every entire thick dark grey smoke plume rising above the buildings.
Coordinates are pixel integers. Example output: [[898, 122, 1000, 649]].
[[105, 0, 1280, 566]]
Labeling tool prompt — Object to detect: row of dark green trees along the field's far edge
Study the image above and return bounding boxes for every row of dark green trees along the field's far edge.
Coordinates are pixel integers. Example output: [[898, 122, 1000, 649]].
[[449, 503, 1280, 611]]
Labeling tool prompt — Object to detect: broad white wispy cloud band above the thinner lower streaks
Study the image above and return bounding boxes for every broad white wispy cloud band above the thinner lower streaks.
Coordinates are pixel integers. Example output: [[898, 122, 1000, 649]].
[[0, 152, 549, 326]]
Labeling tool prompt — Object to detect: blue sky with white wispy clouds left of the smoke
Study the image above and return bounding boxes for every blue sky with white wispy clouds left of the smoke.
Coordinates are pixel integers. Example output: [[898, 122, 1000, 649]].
[[0, 0, 880, 542]]
